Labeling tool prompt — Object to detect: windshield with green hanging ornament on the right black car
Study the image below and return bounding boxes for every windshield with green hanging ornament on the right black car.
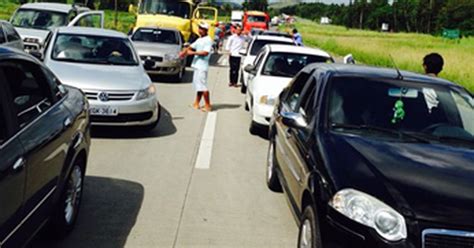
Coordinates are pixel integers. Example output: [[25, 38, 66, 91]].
[[328, 77, 474, 142]]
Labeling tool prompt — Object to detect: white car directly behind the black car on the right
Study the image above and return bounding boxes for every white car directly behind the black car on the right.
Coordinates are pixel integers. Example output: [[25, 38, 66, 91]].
[[244, 45, 334, 133]]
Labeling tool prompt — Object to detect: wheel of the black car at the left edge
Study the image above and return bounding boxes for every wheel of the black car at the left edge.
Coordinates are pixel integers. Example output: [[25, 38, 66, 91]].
[[49, 160, 85, 238]]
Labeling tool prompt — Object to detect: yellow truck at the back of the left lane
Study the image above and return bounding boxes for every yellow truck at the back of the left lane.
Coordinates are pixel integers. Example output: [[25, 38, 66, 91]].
[[130, 0, 217, 42]]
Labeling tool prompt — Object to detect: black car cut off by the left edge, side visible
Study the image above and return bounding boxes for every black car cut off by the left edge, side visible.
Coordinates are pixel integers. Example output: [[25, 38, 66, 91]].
[[0, 46, 90, 248]]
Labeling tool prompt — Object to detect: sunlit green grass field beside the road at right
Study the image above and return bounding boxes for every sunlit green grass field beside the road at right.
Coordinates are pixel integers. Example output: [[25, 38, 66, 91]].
[[284, 20, 474, 92]]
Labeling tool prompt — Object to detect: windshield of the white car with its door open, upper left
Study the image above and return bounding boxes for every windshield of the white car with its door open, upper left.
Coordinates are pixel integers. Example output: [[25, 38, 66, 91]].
[[12, 9, 67, 30]]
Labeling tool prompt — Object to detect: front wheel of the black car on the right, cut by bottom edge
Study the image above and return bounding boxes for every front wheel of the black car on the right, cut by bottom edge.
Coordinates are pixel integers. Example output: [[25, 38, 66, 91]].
[[298, 205, 322, 248]]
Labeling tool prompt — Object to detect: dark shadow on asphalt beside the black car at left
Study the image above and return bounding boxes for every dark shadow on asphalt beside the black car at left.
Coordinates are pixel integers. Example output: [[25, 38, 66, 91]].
[[30, 176, 145, 248]]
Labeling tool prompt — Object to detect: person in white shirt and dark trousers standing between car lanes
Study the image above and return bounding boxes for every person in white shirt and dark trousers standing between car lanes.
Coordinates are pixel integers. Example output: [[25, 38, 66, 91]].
[[226, 25, 245, 87]]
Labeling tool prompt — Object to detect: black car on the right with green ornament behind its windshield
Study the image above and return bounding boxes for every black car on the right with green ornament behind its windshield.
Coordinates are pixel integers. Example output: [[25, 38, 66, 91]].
[[267, 64, 474, 248]]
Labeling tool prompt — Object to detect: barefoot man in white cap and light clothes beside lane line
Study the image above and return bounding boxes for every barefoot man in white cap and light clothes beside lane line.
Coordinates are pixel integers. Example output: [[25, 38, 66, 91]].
[[180, 22, 213, 112]]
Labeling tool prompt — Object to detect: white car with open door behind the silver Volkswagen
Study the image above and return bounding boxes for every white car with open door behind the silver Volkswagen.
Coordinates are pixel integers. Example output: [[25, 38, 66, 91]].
[[10, 3, 104, 51]]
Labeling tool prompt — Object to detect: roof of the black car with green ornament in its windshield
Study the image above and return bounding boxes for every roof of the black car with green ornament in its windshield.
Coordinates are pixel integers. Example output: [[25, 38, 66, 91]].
[[303, 63, 461, 87]]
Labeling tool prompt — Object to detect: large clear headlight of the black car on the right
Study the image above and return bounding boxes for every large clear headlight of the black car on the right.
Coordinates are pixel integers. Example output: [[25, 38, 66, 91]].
[[329, 189, 407, 241]]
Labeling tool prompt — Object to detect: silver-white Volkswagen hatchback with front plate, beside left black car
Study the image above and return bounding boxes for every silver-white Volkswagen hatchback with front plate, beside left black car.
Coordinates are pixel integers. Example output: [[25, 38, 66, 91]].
[[43, 27, 160, 129]]
